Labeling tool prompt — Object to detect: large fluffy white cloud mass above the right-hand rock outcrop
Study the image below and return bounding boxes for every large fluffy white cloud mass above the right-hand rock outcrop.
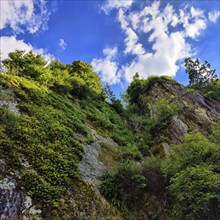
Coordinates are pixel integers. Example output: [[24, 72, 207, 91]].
[[97, 0, 220, 84]]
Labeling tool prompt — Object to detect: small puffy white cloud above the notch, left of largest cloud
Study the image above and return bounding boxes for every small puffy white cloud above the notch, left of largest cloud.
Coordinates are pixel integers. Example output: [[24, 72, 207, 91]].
[[91, 47, 121, 85]]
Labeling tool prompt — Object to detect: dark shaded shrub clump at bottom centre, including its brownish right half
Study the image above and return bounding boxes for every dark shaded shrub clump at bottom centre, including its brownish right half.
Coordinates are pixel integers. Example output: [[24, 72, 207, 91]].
[[100, 158, 165, 219]]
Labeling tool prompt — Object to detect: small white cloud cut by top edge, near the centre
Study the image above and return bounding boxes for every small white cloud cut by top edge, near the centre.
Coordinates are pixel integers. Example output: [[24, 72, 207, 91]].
[[102, 0, 133, 14]]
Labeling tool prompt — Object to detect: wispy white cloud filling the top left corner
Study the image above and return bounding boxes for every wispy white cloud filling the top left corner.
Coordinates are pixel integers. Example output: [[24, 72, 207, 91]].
[[0, 0, 51, 34]]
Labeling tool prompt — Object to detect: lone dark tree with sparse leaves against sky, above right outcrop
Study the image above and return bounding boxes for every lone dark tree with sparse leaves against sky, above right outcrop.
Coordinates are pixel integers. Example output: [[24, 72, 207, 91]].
[[184, 57, 216, 87]]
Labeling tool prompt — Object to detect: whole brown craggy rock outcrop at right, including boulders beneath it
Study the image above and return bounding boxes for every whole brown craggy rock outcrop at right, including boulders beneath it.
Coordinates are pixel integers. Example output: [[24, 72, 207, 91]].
[[144, 79, 220, 155]]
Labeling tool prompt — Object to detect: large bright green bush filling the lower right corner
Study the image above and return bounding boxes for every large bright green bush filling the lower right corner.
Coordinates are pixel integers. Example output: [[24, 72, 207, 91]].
[[162, 134, 220, 219]]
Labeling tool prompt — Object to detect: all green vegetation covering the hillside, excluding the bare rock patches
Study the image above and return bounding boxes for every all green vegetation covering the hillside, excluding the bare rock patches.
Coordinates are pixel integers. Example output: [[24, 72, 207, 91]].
[[0, 51, 220, 220]]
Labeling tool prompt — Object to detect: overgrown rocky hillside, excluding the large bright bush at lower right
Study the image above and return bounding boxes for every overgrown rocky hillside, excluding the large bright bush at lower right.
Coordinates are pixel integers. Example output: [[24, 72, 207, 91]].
[[0, 52, 220, 219]]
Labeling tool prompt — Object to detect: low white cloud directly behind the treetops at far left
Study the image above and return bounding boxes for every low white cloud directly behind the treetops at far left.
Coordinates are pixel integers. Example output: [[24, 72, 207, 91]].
[[0, 36, 54, 61]]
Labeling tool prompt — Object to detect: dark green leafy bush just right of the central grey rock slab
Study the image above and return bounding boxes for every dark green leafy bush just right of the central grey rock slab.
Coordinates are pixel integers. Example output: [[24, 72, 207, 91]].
[[100, 161, 147, 209]]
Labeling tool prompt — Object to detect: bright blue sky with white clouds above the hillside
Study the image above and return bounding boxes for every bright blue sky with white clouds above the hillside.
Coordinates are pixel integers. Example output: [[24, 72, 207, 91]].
[[0, 0, 220, 95]]
